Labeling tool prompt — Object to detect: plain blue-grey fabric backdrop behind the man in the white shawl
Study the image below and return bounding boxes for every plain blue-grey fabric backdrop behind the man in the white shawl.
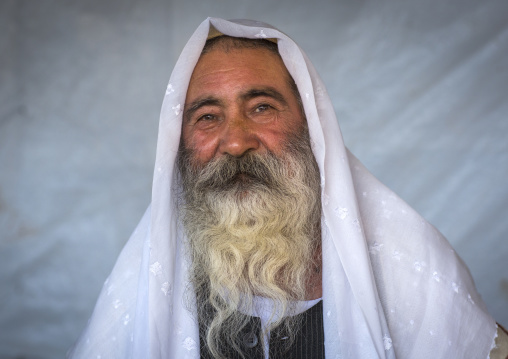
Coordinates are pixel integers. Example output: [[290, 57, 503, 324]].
[[0, 0, 508, 358]]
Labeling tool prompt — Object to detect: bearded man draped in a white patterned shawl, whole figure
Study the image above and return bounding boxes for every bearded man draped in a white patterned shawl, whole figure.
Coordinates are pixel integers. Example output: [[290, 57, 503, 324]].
[[68, 19, 506, 358]]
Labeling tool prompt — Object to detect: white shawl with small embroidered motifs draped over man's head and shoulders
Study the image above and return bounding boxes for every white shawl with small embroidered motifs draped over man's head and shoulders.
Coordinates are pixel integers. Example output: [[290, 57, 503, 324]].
[[67, 18, 496, 358]]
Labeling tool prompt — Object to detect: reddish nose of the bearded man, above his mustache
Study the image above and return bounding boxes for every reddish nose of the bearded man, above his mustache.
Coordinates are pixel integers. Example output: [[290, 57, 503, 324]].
[[219, 118, 260, 157]]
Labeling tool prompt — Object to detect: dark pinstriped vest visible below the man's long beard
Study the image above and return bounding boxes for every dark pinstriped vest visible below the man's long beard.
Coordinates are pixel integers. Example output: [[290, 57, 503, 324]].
[[199, 301, 325, 359]]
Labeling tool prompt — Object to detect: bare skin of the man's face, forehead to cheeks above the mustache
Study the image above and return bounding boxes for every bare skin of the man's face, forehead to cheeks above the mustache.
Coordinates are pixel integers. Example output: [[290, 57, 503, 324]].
[[182, 48, 304, 167]]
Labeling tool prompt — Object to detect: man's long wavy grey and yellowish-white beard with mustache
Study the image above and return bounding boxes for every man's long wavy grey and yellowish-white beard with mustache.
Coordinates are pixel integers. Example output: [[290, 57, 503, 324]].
[[178, 131, 321, 358]]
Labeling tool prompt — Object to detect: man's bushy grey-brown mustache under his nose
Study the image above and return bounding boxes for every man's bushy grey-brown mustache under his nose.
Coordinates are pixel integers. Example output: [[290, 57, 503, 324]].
[[190, 152, 283, 191]]
